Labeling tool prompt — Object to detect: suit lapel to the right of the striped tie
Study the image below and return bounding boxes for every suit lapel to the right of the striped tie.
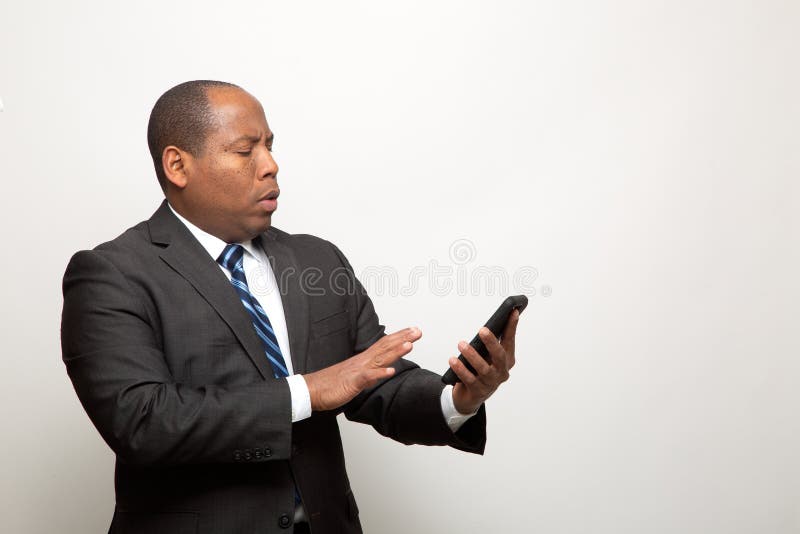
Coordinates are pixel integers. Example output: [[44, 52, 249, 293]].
[[261, 228, 309, 374]]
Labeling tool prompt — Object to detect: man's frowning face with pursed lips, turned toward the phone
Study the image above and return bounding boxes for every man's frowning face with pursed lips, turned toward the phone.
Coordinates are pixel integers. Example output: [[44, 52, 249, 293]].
[[180, 88, 280, 243]]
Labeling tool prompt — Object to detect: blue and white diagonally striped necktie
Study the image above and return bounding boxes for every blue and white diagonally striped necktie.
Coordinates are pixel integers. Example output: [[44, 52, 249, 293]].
[[217, 245, 289, 378]]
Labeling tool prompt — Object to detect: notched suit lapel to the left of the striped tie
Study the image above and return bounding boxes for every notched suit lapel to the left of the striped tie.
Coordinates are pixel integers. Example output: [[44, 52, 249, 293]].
[[148, 201, 276, 379]]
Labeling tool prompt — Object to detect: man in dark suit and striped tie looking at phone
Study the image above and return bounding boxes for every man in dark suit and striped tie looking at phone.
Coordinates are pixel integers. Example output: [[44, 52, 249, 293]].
[[62, 81, 518, 534]]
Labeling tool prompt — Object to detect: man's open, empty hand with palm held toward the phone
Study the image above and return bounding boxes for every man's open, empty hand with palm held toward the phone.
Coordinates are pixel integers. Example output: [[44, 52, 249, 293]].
[[303, 327, 422, 411]]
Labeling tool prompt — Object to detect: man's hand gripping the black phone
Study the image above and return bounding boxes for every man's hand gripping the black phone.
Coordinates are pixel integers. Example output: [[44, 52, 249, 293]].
[[450, 310, 519, 414]]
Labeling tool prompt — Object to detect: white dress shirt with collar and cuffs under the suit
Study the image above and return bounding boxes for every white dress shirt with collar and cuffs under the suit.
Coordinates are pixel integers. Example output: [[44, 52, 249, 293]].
[[170, 206, 477, 432]]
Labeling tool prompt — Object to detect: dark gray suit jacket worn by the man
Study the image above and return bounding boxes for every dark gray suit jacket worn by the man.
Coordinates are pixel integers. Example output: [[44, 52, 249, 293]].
[[61, 202, 485, 534]]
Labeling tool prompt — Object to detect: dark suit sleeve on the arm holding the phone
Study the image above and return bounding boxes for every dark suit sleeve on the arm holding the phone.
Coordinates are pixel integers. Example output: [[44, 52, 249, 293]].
[[324, 245, 486, 454]]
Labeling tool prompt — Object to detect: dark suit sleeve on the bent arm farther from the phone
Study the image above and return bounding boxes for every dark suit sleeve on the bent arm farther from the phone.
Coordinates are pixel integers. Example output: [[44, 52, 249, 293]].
[[61, 251, 291, 464]]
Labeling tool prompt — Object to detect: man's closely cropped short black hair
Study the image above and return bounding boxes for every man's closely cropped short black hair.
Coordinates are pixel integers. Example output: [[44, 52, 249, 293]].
[[147, 80, 241, 192]]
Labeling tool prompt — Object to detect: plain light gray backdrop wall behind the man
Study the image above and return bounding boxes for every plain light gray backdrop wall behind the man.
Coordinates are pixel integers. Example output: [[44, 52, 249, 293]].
[[0, 0, 800, 534]]
